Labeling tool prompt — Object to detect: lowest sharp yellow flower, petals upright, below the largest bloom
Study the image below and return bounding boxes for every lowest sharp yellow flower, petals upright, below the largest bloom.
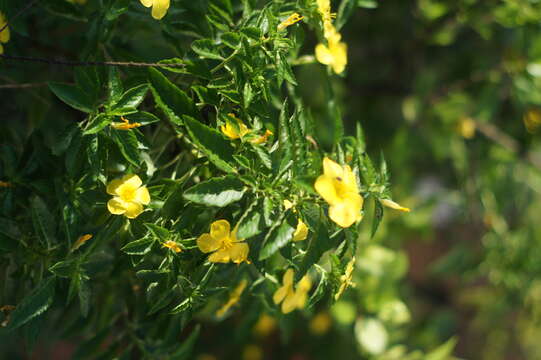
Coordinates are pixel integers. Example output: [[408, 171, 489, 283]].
[[272, 269, 312, 314]]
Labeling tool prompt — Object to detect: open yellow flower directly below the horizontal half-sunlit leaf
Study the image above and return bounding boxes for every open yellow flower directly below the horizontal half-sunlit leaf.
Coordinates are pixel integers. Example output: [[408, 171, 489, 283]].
[[197, 220, 250, 264]]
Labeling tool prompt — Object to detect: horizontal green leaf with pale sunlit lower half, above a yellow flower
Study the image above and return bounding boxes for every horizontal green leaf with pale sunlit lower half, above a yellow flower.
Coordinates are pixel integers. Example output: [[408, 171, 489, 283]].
[[184, 176, 245, 207]]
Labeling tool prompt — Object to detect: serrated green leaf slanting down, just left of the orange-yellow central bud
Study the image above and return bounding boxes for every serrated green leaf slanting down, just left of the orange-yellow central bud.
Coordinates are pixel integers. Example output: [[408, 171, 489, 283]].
[[183, 116, 236, 173]]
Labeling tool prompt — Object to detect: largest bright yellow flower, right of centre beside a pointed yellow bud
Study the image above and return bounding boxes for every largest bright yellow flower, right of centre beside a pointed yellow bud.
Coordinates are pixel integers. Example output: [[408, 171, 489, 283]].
[[314, 158, 364, 228]]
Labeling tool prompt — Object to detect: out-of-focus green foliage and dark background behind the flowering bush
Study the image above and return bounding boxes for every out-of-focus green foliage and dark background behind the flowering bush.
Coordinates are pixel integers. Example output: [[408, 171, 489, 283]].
[[0, 0, 541, 360]]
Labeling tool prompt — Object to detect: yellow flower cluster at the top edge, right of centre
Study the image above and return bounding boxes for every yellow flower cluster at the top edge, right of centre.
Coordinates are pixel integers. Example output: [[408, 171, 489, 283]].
[[316, 0, 348, 74]]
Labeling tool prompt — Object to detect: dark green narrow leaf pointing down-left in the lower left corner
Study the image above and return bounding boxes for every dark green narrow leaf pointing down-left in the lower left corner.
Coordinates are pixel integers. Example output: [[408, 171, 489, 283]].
[[8, 277, 56, 330]]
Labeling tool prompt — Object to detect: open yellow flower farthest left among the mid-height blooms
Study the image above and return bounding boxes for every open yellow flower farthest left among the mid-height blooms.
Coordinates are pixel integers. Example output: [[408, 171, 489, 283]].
[[107, 174, 150, 219]]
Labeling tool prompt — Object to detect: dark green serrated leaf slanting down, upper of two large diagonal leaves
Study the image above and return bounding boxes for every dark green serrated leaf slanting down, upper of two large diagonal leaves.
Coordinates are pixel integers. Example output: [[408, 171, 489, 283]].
[[149, 68, 197, 125]]
